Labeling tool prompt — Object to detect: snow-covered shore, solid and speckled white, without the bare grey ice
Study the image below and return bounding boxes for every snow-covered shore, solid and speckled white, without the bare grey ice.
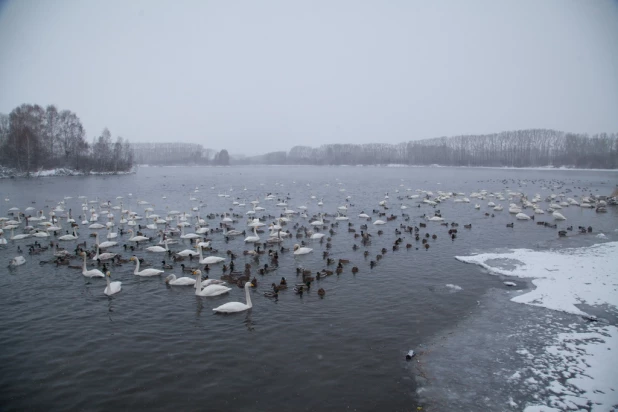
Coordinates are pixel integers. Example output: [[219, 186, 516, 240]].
[[447, 242, 618, 412]]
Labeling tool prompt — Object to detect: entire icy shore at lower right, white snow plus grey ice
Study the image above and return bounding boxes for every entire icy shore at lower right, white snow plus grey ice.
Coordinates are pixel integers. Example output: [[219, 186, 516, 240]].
[[417, 241, 618, 412]]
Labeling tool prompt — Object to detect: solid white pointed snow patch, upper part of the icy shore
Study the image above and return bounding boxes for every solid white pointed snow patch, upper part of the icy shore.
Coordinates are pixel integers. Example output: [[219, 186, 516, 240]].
[[455, 242, 618, 315]]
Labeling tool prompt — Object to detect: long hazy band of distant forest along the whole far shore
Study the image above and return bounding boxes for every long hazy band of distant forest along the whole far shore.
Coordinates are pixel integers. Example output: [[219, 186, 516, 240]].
[[133, 129, 618, 169]]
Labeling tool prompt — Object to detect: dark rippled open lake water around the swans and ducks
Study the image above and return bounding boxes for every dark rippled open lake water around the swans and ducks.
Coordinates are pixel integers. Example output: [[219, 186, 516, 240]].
[[0, 167, 617, 411]]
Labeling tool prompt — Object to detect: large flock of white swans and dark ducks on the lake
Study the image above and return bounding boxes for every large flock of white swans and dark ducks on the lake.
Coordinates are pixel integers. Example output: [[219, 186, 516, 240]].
[[0, 179, 614, 313]]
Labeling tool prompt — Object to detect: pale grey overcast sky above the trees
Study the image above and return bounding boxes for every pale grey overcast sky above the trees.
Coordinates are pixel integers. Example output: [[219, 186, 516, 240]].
[[0, 0, 618, 155]]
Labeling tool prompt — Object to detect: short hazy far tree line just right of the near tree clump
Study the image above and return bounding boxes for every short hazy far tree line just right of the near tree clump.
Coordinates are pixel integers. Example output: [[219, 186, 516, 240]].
[[133, 143, 230, 166]]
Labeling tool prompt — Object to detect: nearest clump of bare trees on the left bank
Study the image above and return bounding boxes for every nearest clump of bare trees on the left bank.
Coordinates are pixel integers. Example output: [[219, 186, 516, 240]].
[[0, 104, 133, 173]]
